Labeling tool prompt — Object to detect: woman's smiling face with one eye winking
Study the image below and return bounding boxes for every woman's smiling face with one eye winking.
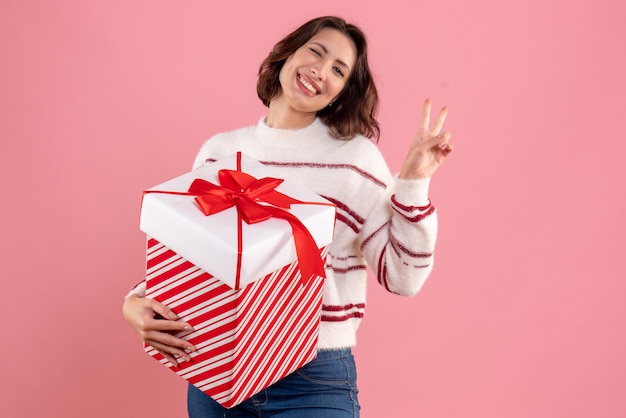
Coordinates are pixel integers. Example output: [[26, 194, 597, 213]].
[[278, 28, 356, 113]]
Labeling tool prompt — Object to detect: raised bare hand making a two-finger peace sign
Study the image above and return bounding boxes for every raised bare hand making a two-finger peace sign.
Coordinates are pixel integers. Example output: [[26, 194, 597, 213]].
[[399, 99, 454, 179]]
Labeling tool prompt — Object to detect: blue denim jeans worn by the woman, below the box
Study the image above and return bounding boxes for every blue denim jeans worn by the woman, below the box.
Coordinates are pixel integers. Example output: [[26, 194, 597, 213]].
[[187, 348, 361, 418]]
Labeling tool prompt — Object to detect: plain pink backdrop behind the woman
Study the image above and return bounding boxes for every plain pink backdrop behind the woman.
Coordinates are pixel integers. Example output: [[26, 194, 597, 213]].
[[0, 0, 626, 418]]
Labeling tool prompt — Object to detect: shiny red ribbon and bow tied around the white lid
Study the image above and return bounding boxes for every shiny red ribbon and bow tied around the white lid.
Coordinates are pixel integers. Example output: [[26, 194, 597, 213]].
[[144, 164, 326, 289]]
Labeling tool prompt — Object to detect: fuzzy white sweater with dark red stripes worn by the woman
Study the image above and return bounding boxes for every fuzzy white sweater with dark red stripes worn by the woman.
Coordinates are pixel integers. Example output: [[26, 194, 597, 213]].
[[133, 118, 437, 349]]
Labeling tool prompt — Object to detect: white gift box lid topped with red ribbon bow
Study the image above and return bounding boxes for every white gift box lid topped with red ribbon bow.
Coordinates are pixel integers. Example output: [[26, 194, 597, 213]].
[[140, 153, 335, 288]]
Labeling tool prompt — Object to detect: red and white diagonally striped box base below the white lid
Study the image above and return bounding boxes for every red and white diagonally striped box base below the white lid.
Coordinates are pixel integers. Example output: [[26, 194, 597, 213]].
[[145, 239, 325, 408]]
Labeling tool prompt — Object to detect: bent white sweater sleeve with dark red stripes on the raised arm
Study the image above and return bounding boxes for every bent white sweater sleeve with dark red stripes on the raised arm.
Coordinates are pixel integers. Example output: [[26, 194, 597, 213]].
[[361, 176, 437, 296]]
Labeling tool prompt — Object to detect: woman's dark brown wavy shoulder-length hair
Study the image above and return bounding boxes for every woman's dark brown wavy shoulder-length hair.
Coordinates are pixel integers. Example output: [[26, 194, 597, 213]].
[[257, 16, 380, 140]]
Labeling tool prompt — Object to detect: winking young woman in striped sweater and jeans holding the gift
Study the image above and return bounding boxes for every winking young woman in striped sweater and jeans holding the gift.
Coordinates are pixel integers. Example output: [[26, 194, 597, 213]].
[[123, 17, 453, 418]]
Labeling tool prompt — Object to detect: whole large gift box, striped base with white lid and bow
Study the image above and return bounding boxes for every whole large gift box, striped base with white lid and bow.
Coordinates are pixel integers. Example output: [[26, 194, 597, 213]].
[[141, 153, 335, 408]]
